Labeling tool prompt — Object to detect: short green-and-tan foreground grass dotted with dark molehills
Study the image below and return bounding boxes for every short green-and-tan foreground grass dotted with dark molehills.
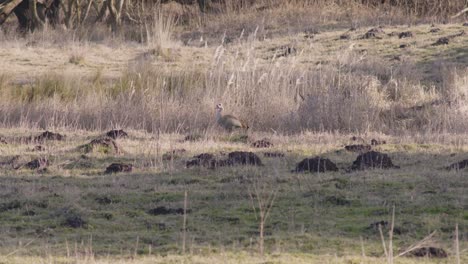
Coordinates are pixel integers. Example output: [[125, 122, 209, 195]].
[[0, 128, 468, 262]]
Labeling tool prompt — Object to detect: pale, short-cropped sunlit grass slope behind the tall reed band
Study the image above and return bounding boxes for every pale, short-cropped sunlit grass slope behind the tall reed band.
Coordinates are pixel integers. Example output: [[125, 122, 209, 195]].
[[0, 24, 468, 83]]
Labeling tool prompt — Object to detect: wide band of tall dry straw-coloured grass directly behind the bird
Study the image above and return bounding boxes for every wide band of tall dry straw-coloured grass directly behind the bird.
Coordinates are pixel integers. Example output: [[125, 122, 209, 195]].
[[0, 40, 468, 134]]
